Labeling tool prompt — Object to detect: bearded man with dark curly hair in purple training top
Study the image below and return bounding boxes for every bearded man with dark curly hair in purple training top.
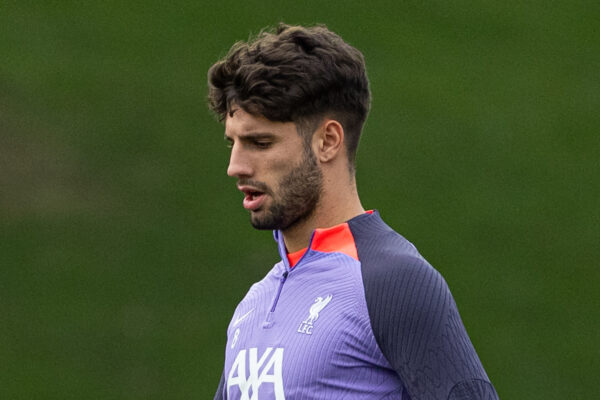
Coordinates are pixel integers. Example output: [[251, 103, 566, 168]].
[[208, 25, 497, 400]]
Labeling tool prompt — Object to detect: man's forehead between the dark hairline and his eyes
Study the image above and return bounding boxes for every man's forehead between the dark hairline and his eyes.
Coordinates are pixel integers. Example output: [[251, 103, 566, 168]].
[[225, 108, 299, 137]]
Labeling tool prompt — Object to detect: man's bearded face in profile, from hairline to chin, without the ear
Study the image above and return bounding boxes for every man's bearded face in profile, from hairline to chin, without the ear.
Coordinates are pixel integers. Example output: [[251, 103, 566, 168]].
[[225, 108, 323, 230]]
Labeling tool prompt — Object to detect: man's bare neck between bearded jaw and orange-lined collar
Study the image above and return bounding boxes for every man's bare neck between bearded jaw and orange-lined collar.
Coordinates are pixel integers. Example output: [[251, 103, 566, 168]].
[[282, 178, 365, 253]]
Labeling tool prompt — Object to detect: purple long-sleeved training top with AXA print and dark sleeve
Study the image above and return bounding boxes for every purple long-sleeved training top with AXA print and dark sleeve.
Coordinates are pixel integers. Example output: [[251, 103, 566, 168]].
[[215, 211, 498, 400]]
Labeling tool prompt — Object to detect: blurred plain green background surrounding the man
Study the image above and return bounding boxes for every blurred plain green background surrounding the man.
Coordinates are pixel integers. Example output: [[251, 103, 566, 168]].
[[0, 1, 600, 399]]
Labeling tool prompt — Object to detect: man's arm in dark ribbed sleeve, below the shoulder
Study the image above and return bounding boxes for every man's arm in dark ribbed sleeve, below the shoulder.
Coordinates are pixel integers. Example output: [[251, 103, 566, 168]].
[[363, 255, 498, 400]]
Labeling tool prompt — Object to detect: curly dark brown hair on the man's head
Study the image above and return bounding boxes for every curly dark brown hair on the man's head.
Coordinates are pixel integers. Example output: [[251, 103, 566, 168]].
[[208, 24, 371, 168]]
